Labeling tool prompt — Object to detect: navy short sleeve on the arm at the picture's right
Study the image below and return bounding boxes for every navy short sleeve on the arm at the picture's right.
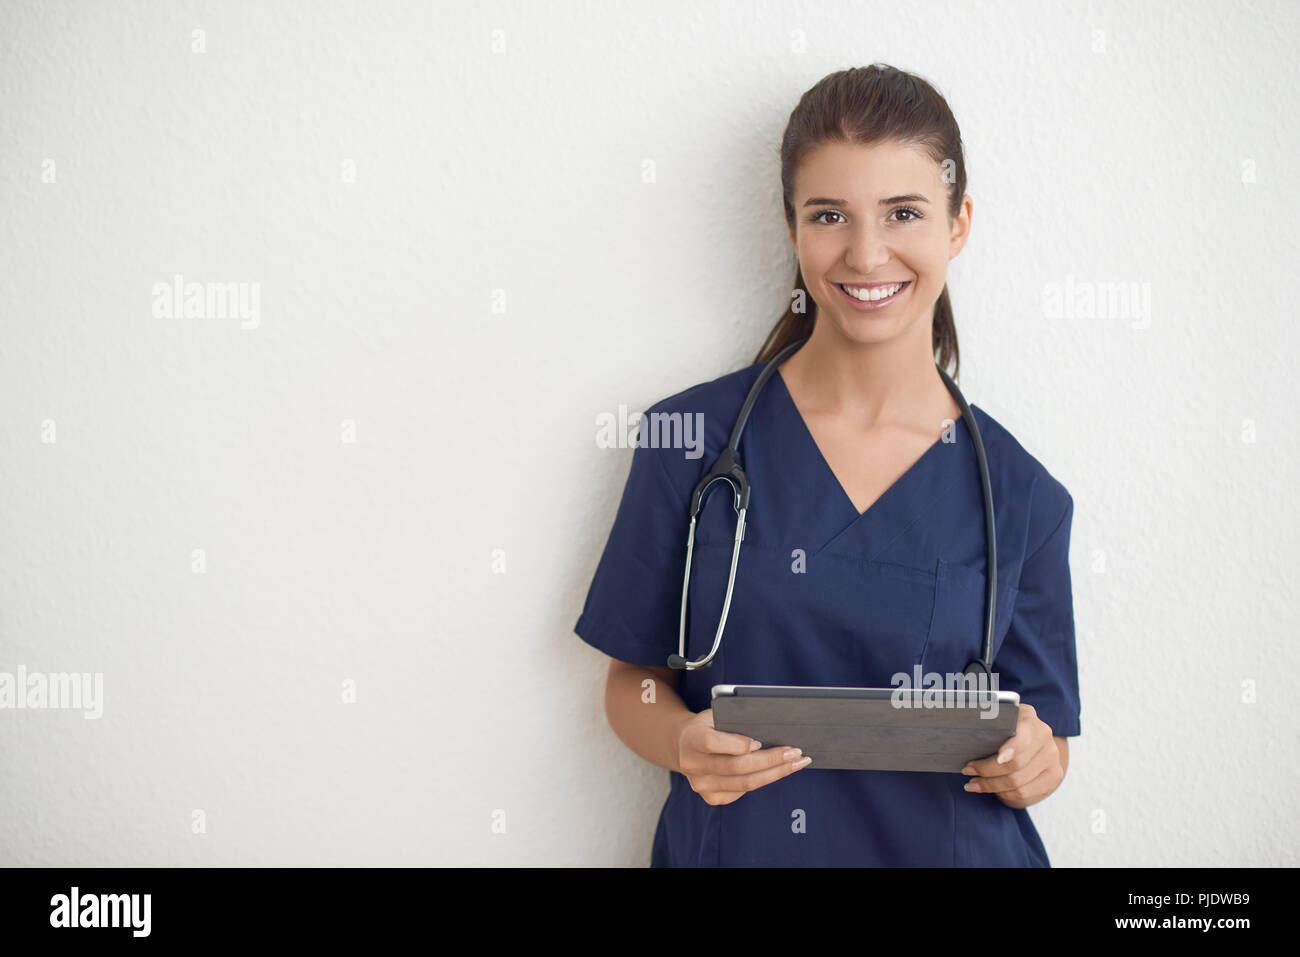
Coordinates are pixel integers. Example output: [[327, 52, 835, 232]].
[[995, 493, 1079, 737]]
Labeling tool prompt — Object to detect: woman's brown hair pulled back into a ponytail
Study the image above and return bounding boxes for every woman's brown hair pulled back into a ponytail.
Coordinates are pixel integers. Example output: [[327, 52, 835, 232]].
[[754, 64, 966, 380]]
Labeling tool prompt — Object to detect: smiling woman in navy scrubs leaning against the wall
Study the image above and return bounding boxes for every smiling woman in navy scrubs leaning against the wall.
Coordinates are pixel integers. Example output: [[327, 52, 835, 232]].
[[576, 65, 1079, 866]]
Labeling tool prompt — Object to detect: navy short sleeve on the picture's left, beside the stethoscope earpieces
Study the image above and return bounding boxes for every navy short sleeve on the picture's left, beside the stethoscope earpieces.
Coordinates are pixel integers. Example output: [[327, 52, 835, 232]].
[[573, 434, 689, 667]]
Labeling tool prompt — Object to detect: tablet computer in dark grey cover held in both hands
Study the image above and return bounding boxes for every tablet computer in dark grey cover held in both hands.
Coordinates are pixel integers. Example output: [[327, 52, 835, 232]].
[[712, 684, 1021, 774]]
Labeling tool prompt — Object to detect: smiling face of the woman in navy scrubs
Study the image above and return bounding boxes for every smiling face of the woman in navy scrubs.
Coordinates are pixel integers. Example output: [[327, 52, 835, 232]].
[[790, 140, 971, 351]]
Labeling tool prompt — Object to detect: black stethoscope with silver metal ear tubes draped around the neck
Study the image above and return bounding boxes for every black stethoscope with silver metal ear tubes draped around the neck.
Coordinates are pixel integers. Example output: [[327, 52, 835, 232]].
[[668, 338, 997, 687]]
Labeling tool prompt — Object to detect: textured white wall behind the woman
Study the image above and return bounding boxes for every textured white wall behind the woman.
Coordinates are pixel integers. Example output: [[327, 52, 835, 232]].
[[0, 0, 1300, 866]]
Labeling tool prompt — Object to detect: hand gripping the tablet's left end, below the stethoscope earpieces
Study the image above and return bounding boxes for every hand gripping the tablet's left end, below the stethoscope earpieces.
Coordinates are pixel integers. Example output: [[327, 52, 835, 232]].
[[677, 707, 813, 804]]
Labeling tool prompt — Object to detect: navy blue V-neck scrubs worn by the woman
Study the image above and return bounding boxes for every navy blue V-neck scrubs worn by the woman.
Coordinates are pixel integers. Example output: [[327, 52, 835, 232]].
[[575, 364, 1079, 867]]
